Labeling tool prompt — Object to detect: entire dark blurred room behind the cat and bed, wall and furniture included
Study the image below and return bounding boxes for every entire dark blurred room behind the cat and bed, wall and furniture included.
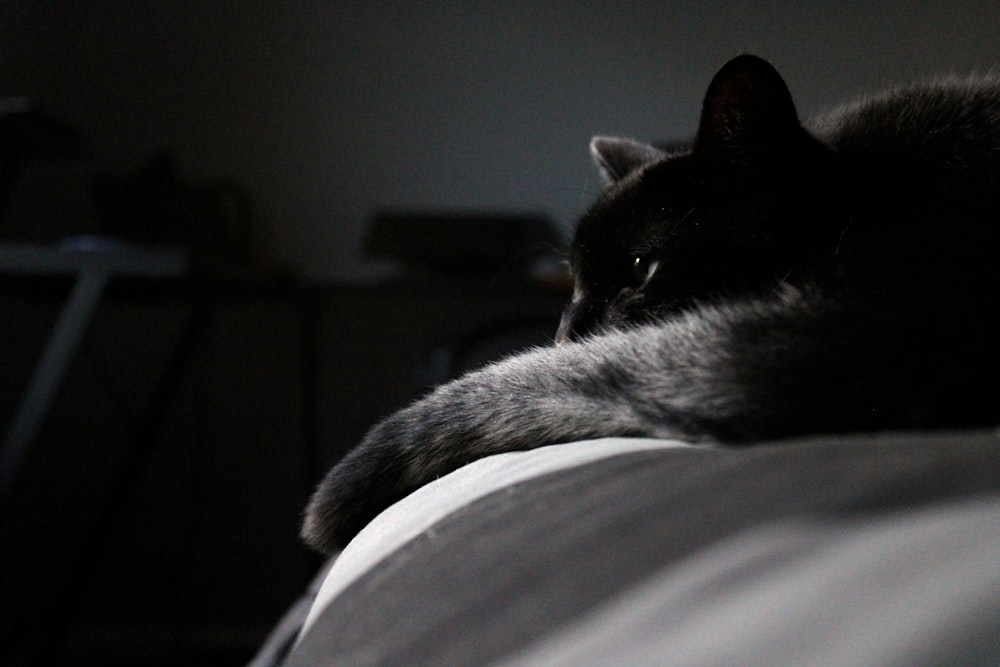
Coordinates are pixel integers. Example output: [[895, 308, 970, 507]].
[[0, 0, 1000, 665]]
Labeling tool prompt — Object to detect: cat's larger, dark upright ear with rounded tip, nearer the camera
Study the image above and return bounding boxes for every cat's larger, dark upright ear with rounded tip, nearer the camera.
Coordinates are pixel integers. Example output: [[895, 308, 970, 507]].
[[695, 55, 801, 157]]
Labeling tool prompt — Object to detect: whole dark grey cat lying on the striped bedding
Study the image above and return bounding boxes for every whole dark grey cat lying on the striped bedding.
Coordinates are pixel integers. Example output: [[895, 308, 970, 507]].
[[303, 56, 1000, 551]]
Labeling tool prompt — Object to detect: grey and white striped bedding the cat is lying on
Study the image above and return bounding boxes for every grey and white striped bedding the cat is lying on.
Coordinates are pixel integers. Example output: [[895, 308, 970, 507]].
[[255, 429, 1000, 667]]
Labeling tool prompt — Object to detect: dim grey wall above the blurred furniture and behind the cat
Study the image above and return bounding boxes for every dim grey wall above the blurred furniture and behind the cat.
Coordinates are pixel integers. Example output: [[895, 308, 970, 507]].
[[7, 0, 1000, 279]]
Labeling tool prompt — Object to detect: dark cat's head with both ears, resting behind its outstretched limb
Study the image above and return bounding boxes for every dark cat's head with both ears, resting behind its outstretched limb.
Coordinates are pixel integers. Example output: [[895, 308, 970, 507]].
[[557, 55, 843, 341]]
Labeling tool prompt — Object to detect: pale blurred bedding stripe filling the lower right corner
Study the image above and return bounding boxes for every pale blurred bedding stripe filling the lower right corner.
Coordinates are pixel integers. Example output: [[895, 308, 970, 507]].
[[500, 497, 1000, 667]]
